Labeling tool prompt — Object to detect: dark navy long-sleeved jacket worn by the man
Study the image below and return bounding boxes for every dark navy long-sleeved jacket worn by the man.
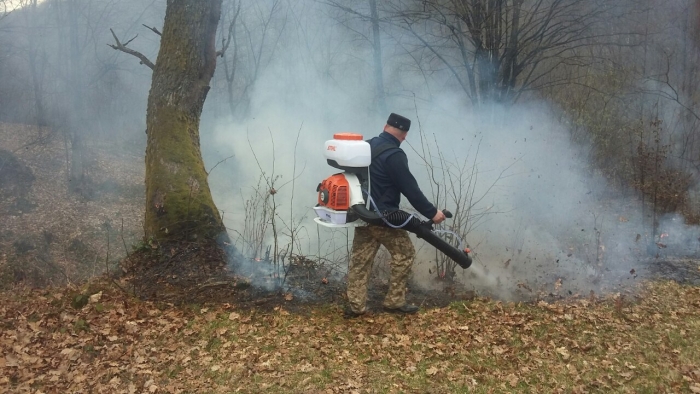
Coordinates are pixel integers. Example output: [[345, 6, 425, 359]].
[[369, 132, 437, 219]]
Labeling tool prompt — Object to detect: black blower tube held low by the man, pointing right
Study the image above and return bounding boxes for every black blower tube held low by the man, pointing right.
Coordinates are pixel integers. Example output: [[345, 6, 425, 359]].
[[351, 204, 472, 269]]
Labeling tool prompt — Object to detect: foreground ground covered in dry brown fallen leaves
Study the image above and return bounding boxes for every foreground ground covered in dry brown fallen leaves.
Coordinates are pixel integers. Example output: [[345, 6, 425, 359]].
[[0, 280, 700, 393]]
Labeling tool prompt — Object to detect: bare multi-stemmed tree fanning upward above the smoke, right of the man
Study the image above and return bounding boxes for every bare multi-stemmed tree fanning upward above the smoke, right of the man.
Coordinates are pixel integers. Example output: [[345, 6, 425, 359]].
[[393, 0, 611, 106]]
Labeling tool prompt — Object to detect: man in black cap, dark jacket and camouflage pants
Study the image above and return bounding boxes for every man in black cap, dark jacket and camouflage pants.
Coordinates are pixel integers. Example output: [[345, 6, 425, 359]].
[[344, 113, 445, 318]]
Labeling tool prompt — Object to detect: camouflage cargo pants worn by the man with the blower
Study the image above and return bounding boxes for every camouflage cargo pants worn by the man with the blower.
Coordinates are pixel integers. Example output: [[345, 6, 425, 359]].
[[347, 226, 416, 313]]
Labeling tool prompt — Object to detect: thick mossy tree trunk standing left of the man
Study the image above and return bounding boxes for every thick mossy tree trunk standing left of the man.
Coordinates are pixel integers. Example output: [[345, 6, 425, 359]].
[[144, 0, 225, 242]]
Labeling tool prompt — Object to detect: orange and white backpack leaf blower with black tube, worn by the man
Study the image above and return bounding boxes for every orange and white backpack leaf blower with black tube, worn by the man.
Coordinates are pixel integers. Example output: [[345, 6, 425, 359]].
[[314, 133, 472, 269]]
